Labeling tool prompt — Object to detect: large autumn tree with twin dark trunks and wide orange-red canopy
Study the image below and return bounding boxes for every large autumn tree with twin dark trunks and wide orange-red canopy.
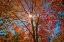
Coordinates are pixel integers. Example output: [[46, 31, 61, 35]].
[[0, 0, 64, 42]]
